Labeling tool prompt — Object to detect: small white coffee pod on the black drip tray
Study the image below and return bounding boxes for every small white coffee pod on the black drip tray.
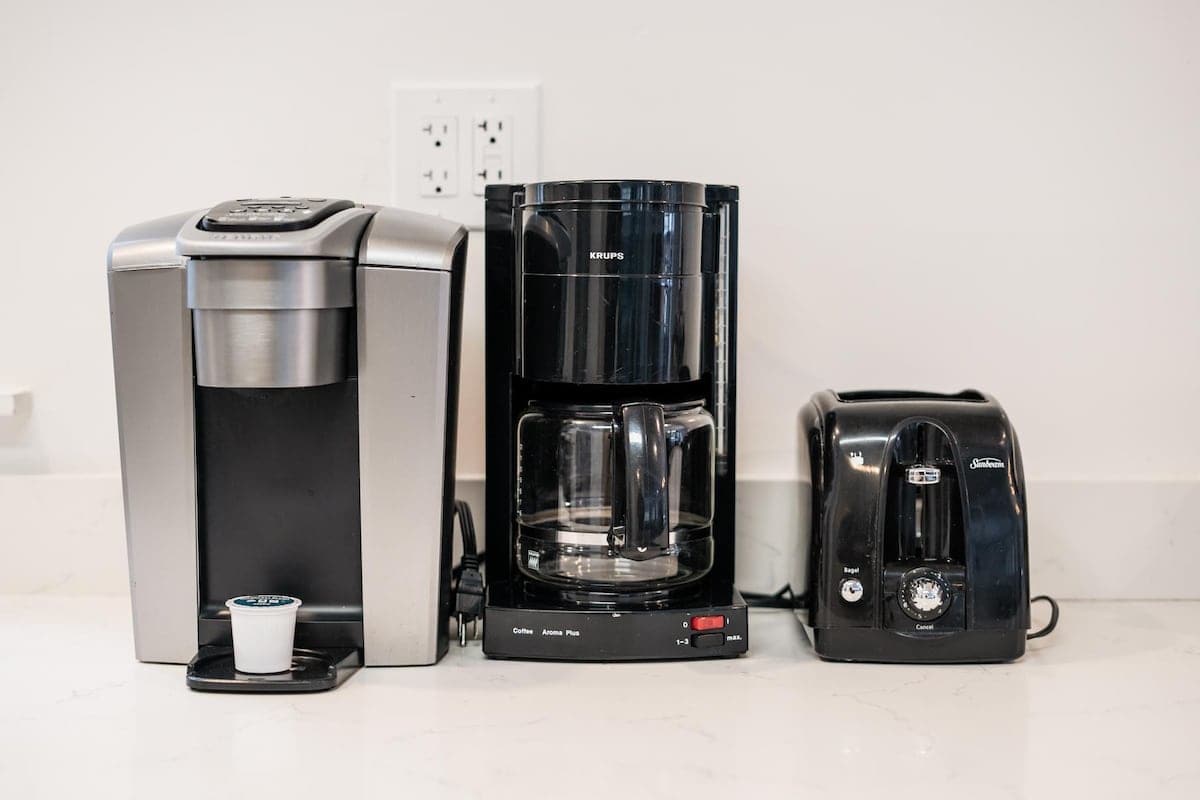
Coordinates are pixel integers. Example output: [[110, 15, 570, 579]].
[[226, 595, 300, 675]]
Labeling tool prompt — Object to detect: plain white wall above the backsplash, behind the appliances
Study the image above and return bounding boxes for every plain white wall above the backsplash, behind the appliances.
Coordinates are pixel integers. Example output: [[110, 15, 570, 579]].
[[0, 0, 1200, 594]]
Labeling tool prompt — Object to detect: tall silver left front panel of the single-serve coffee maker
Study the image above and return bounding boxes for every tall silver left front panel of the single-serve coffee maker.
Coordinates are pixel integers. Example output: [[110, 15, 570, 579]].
[[108, 267, 199, 663]]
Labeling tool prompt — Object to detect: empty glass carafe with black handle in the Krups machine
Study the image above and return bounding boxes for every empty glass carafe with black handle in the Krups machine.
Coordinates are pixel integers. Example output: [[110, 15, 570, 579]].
[[516, 401, 714, 596]]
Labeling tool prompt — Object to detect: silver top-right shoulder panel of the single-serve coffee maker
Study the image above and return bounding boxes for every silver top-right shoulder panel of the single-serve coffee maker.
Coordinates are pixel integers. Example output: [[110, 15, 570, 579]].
[[359, 209, 467, 272]]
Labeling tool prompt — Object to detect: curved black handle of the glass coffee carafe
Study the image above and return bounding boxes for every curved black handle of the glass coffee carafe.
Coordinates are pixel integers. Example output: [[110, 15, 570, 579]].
[[620, 403, 671, 561]]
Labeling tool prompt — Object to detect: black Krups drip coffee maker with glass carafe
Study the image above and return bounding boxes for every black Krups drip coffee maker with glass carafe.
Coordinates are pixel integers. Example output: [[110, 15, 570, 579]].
[[484, 180, 748, 661]]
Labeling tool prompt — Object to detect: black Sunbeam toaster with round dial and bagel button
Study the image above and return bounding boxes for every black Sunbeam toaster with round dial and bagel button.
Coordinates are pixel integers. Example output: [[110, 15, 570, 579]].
[[794, 391, 1030, 662]]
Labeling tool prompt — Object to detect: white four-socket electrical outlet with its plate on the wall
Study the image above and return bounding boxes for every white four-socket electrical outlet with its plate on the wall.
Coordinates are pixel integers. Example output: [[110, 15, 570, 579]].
[[391, 84, 541, 228]]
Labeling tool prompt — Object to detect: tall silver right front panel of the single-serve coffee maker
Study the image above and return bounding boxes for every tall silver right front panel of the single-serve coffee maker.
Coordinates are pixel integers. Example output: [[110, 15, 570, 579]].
[[358, 266, 450, 666]]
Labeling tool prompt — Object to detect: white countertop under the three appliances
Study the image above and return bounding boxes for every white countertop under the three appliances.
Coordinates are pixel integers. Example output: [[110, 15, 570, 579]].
[[0, 596, 1200, 800]]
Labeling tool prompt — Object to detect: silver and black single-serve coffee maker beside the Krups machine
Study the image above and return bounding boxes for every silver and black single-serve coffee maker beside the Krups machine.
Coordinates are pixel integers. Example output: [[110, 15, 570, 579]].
[[108, 197, 467, 691]]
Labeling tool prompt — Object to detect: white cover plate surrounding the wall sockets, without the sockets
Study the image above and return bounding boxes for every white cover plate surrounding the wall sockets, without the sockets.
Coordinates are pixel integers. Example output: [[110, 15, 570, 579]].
[[391, 84, 541, 229]]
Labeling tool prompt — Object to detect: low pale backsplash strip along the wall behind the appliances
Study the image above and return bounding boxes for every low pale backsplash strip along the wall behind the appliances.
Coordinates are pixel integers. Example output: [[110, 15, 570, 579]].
[[0, 475, 1200, 600]]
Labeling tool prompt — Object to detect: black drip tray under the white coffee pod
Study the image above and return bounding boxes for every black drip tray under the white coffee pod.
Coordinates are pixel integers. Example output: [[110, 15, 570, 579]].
[[187, 646, 362, 692]]
